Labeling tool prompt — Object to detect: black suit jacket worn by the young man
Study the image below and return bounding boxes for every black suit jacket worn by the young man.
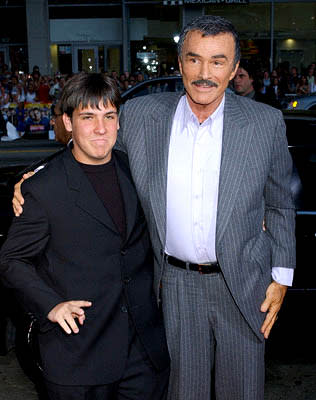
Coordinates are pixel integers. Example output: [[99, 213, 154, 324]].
[[0, 150, 169, 385]]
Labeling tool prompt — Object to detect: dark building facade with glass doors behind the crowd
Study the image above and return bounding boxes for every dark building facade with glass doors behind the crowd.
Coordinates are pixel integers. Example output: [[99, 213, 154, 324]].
[[0, 0, 316, 74]]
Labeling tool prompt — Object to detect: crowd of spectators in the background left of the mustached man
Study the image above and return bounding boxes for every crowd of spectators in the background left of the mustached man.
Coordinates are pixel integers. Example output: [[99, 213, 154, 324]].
[[0, 65, 179, 136]]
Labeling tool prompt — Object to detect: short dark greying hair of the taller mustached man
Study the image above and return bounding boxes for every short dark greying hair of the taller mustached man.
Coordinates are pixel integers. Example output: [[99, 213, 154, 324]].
[[177, 15, 240, 68]]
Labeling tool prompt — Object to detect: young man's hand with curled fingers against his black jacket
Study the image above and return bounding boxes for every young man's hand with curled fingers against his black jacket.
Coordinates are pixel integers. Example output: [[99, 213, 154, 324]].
[[47, 300, 92, 334]]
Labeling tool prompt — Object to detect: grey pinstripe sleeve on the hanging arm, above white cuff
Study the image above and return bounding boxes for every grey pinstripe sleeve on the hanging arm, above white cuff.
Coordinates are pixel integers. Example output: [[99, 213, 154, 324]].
[[264, 111, 296, 268]]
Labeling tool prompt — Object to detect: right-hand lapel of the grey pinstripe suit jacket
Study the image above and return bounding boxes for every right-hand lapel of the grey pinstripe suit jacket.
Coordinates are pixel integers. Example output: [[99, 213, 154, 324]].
[[216, 95, 253, 243]]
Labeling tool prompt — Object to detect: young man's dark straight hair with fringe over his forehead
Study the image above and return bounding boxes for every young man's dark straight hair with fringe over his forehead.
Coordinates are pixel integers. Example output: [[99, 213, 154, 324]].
[[59, 72, 121, 117]]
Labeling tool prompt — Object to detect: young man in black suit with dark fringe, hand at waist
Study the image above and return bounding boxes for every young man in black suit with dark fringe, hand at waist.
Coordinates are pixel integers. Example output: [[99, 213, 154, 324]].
[[0, 73, 169, 400]]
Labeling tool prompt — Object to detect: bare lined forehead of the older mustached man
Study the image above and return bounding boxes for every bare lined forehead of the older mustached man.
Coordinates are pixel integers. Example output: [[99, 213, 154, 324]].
[[182, 31, 235, 56]]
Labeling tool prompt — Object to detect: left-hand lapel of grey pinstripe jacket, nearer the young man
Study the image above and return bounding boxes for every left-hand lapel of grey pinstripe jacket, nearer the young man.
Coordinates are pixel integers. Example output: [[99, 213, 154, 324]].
[[144, 93, 183, 246]]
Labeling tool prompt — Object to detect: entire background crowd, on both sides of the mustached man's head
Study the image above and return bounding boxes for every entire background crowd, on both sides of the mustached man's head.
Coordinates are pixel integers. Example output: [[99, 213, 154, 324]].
[[0, 60, 316, 136]]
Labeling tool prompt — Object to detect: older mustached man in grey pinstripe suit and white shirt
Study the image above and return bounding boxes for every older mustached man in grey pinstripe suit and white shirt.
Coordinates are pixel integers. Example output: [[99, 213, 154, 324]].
[[119, 16, 295, 400]]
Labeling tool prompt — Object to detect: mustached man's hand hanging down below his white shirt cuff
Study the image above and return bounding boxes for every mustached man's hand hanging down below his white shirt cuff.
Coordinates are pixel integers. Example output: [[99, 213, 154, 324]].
[[260, 281, 287, 339]]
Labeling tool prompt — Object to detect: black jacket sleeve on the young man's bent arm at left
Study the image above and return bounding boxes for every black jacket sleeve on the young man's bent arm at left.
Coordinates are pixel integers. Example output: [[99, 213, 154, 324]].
[[0, 185, 64, 325]]
